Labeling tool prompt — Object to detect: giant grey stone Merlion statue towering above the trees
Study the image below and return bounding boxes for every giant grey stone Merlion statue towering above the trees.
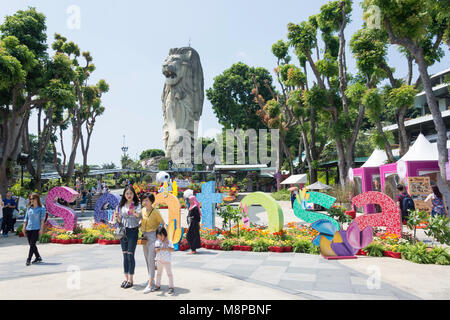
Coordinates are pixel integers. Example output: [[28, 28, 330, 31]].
[[162, 47, 204, 162]]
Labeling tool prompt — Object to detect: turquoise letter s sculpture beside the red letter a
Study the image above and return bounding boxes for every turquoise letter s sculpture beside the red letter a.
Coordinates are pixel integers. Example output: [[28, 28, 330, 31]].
[[294, 188, 340, 230]]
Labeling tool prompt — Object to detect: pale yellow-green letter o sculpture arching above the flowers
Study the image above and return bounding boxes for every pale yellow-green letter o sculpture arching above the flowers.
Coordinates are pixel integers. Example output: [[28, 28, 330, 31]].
[[240, 191, 284, 232]]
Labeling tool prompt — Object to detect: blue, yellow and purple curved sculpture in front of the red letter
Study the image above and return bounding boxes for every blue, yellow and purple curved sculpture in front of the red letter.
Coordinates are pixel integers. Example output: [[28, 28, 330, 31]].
[[311, 220, 358, 257]]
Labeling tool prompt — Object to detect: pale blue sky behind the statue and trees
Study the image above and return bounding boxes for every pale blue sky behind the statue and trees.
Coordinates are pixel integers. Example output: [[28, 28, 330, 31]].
[[0, 0, 450, 165]]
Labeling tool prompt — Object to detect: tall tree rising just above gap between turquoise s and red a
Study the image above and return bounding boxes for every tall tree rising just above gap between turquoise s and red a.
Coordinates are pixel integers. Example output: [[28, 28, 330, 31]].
[[288, 0, 365, 184]]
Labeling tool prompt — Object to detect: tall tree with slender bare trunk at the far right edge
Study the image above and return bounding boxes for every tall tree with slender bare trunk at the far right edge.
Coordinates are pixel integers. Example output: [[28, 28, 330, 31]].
[[363, 0, 450, 179]]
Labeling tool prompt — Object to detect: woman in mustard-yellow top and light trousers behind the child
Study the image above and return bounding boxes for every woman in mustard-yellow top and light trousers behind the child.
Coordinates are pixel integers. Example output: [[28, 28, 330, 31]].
[[141, 192, 164, 293]]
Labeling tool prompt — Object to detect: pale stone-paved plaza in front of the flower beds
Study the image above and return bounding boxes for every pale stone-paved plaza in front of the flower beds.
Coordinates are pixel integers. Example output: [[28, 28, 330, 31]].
[[0, 236, 442, 300]]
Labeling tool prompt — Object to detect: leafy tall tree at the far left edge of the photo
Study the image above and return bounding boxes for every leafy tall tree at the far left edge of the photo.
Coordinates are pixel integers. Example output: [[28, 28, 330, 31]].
[[0, 8, 60, 194]]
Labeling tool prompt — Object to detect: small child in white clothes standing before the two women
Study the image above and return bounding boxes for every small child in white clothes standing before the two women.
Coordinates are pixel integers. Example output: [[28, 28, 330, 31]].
[[155, 227, 174, 294]]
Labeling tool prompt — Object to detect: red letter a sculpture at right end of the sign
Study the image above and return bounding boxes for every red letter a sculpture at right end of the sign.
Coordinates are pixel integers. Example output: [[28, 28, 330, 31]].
[[349, 191, 402, 239]]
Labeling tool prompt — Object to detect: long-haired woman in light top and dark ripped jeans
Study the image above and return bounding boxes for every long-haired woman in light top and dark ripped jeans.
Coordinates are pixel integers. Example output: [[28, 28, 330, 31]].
[[115, 187, 142, 289]]
